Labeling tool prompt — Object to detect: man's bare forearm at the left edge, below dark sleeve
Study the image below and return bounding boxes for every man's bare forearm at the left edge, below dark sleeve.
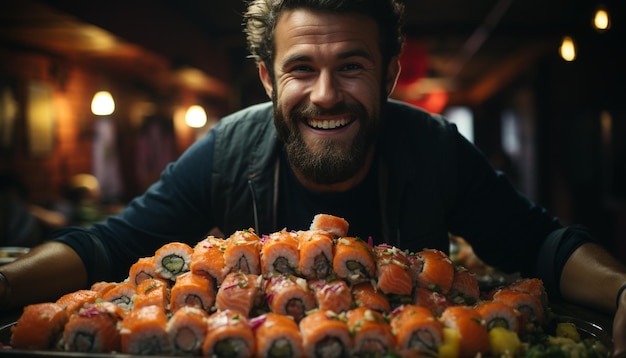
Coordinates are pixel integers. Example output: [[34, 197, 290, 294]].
[[0, 242, 87, 308]]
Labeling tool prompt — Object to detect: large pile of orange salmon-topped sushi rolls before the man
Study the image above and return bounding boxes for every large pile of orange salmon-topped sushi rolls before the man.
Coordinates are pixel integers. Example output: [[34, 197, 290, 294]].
[[11, 214, 608, 357]]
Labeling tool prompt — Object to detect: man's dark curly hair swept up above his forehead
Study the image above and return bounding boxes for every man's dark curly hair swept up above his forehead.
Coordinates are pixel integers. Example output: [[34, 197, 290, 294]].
[[243, 0, 404, 76]]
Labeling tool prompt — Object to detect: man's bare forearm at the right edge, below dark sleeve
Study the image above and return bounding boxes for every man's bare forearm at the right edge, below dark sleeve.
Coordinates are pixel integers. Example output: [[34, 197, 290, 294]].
[[561, 244, 626, 313]]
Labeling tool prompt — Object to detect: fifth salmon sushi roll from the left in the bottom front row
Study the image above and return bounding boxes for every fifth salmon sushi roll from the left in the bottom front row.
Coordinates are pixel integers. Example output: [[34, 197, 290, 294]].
[[202, 310, 256, 358]]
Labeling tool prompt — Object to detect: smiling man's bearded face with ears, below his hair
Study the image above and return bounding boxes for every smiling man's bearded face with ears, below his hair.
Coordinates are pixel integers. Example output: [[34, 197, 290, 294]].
[[261, 10, 396, 184]]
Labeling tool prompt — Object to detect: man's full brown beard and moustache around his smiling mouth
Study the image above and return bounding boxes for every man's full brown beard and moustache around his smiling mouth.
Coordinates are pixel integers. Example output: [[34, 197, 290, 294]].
[[273, 98, 383, 184]]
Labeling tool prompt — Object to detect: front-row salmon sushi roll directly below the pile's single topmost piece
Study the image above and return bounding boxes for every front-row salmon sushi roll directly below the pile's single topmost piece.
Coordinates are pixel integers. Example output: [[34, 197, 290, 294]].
[[299, 310, 352, 358]]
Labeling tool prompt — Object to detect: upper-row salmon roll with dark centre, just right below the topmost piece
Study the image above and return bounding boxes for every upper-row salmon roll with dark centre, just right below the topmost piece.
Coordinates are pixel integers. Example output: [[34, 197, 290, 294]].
[[333, 237, 376, 284]]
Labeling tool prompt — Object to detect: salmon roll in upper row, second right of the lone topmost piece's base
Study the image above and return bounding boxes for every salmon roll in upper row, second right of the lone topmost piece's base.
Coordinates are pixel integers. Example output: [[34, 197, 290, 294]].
[[373, 244, 413, 295]]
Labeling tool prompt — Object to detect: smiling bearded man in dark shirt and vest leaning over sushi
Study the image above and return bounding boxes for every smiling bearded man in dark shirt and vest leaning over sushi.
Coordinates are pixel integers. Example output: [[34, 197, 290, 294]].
[[0, 0, 626, 352]]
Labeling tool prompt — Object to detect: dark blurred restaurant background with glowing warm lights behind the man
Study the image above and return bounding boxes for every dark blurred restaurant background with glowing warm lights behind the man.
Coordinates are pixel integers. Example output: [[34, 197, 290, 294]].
[[0, 0, 626, 260]]
